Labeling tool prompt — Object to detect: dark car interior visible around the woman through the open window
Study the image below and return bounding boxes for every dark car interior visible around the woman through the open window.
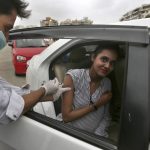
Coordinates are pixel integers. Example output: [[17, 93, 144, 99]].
[[49, 41, 127, 143]]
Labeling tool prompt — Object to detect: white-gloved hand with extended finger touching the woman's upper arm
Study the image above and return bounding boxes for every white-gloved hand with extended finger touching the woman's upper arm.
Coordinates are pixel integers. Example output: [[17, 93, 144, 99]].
[[53, 84, 71, 102]]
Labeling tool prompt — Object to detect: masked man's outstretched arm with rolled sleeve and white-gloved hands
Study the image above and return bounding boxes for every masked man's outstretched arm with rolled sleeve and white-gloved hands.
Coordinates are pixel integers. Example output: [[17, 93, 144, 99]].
[[0, 79, 64, 124]]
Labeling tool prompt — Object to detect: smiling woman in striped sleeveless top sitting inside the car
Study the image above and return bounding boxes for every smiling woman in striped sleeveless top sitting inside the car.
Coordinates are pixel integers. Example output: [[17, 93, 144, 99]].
[[62, 45, 119, 137]]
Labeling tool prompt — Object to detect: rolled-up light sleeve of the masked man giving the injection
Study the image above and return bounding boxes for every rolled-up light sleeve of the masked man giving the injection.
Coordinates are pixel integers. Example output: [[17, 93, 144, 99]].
[[0, 86, 24, 124]]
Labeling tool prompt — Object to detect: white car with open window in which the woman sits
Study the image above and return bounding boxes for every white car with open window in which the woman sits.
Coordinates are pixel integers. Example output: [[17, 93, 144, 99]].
[[0, 20, 150, 150]]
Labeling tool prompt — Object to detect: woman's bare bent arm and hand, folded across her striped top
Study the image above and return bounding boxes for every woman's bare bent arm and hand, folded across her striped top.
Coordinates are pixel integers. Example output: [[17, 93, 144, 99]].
[[62, 75, 112, 122]]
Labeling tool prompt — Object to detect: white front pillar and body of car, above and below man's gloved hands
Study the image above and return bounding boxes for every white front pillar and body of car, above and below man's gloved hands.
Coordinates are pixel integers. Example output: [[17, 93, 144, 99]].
[[26, 39, 71, 119]]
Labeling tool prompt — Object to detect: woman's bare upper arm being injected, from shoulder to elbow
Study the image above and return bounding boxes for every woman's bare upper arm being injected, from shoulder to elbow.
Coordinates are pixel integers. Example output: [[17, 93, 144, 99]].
[[62, 75, 74, 115]]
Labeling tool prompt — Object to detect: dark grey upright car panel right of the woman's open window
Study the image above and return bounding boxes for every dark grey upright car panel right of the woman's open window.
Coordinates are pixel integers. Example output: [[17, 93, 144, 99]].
[[119, 45, 150, 150]]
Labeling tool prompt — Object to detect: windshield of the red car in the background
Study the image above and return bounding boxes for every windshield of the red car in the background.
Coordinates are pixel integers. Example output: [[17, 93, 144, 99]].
[[16, 39, 47, 47]]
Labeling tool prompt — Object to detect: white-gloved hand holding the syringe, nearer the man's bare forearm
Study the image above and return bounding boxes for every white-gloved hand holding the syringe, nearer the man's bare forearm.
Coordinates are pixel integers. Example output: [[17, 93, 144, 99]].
[[41, 78, 59, 96]]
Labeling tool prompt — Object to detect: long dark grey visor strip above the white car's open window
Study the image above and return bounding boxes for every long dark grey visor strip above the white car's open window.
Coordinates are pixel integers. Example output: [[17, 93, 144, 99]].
[[10, 25, 149, 44]]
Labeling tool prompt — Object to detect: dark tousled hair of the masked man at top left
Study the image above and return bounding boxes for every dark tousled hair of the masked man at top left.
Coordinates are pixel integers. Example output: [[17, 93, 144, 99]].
[[0, 0, 31, 18]]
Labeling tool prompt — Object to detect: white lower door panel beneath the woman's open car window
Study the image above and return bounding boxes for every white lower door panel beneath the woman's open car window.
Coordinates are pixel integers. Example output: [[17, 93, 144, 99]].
[[0, 116, 100, 150]]
